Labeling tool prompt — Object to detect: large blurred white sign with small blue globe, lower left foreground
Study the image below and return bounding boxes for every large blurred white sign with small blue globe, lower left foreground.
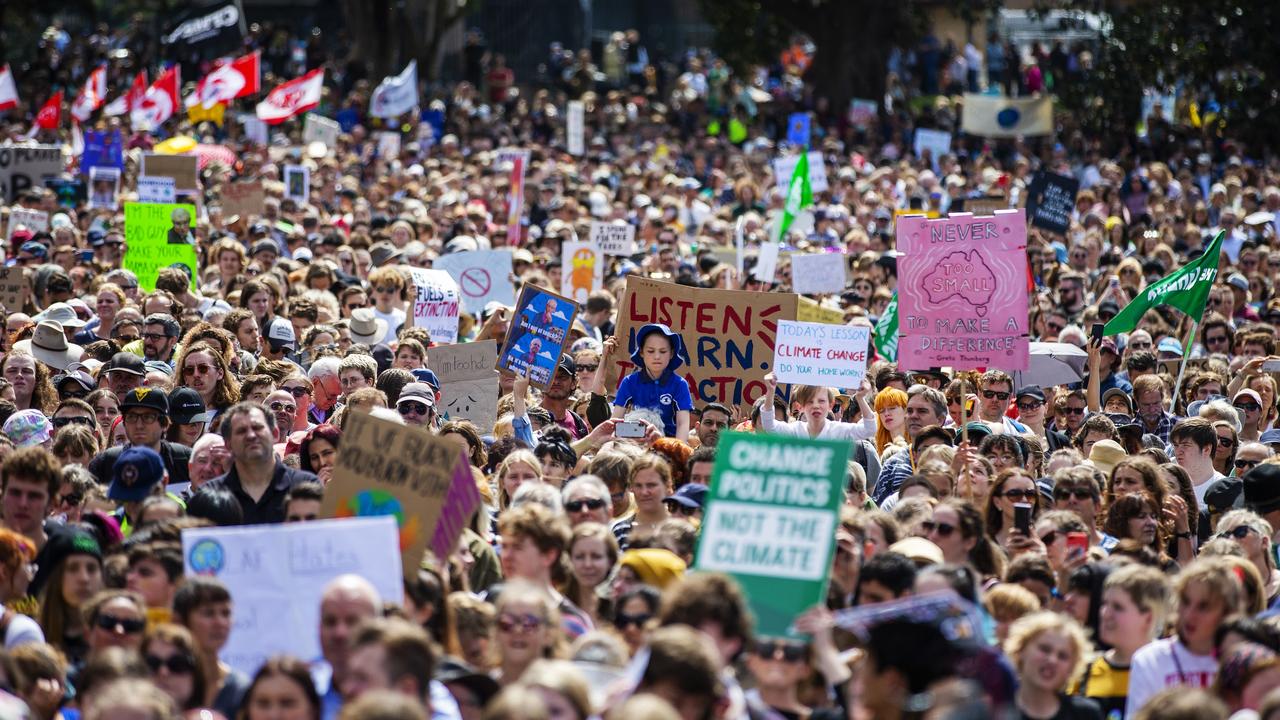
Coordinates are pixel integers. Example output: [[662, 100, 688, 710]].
[[182, 518, 404, 675]]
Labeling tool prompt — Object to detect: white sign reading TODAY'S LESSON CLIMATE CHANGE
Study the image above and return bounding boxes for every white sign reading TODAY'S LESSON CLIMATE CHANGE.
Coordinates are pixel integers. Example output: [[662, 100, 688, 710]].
[[773, 320, 872, 388]]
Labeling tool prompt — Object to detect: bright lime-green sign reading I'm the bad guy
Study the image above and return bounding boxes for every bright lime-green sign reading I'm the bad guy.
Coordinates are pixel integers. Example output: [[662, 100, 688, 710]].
[[124, 202, 197, 292]]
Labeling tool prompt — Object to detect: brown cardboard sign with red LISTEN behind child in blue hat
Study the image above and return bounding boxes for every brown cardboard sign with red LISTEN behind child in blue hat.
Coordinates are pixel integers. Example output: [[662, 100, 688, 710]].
[[602, 275, 797, 415]]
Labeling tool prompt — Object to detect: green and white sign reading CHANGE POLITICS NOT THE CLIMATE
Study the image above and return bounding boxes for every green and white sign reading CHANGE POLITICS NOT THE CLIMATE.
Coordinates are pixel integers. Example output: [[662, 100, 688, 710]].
[[694, 433, 849, 637]]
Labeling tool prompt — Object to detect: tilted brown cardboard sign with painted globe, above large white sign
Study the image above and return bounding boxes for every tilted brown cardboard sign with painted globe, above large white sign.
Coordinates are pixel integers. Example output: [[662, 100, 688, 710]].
[[320, 413, 475, 573]]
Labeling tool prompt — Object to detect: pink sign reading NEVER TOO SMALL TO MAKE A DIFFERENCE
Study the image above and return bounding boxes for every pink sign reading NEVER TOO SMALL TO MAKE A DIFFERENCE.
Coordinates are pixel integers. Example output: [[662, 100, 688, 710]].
[[897, 210, 1029, 370]]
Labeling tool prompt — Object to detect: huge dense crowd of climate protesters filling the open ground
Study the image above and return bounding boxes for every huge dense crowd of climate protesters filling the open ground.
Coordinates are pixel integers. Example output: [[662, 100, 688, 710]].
[[0, 8, 1280, 720]]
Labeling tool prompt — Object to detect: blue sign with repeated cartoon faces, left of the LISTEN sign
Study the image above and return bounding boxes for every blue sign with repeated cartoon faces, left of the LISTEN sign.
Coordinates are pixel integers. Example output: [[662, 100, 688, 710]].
[[498, 284, 577, 389]]
